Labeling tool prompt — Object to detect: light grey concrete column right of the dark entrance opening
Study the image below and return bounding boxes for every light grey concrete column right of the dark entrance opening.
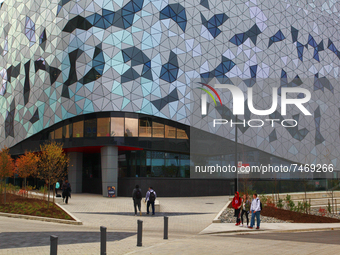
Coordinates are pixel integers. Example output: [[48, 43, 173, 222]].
[[100, 146, 118, 197]]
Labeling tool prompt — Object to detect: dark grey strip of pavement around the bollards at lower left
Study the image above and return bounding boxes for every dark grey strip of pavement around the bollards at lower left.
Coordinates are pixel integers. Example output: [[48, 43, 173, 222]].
[[0, 231, 135, 249]]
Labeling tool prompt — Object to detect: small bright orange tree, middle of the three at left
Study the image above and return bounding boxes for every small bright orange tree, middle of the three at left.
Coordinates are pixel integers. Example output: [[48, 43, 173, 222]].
[[15, 151, 39, 190]]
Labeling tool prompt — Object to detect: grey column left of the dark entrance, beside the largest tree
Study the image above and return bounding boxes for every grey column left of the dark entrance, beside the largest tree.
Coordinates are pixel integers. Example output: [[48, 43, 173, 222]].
[[68, 152, 83, 193]]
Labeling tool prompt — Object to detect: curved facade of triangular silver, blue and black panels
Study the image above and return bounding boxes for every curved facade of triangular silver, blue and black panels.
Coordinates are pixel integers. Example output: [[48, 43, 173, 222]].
[[0, 0, 340, 169]]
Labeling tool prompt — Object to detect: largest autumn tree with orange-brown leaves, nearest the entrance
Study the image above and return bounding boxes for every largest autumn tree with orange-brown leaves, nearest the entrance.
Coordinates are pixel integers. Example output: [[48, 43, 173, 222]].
[[37, 141, 70, 208]]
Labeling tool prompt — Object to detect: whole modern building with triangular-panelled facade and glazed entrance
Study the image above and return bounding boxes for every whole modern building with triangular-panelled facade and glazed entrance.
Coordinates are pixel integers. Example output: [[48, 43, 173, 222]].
[[0, 0, 340, 196]]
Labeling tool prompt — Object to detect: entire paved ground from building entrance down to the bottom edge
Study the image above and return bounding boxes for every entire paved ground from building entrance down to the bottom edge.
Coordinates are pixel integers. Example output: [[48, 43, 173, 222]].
[[0, 194, 340, 255]]
